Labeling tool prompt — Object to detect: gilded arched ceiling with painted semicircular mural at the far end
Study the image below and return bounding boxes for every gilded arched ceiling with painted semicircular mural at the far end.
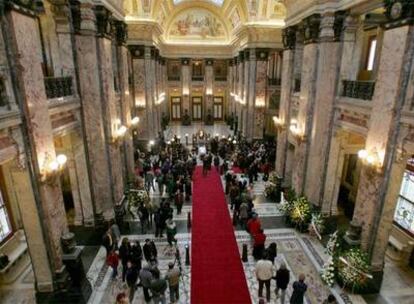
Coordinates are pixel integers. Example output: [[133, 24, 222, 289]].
[[124, 0, 286, 44]]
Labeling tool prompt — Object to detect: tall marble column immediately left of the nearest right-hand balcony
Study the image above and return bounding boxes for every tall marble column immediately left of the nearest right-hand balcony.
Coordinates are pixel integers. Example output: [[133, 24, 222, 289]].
[[305, 13, 342, 206]]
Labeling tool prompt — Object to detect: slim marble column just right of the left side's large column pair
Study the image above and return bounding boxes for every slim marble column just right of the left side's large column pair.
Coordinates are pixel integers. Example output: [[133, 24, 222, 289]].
[[115, 21, 134, 178]]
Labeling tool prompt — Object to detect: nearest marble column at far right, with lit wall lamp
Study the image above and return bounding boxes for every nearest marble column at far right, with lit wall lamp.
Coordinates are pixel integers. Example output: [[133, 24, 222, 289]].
[[353, 22, 414, 271]]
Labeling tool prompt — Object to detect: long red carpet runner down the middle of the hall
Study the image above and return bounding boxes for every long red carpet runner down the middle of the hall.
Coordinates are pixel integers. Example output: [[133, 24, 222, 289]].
[[191, 167, 251, 304]]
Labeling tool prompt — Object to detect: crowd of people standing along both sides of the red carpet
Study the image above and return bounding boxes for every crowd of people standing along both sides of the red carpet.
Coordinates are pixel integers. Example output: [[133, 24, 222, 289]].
[[100, 134, 336, 304]]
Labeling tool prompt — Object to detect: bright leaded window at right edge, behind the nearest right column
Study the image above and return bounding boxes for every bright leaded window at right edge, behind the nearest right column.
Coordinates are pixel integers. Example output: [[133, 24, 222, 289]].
[[394, 170, 414, 234]]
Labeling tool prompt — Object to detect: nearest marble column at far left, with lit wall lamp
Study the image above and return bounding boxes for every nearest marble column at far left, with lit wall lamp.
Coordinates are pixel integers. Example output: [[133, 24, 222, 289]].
[[7, 10, 68, 292]]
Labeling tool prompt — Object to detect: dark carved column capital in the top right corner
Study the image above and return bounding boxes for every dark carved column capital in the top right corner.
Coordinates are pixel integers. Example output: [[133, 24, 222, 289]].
[[384, 0, 414, 29]]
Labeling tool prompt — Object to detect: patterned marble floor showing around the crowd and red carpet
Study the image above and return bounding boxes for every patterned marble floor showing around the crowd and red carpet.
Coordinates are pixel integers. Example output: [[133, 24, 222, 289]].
[[0, 124, 414, 304]]
